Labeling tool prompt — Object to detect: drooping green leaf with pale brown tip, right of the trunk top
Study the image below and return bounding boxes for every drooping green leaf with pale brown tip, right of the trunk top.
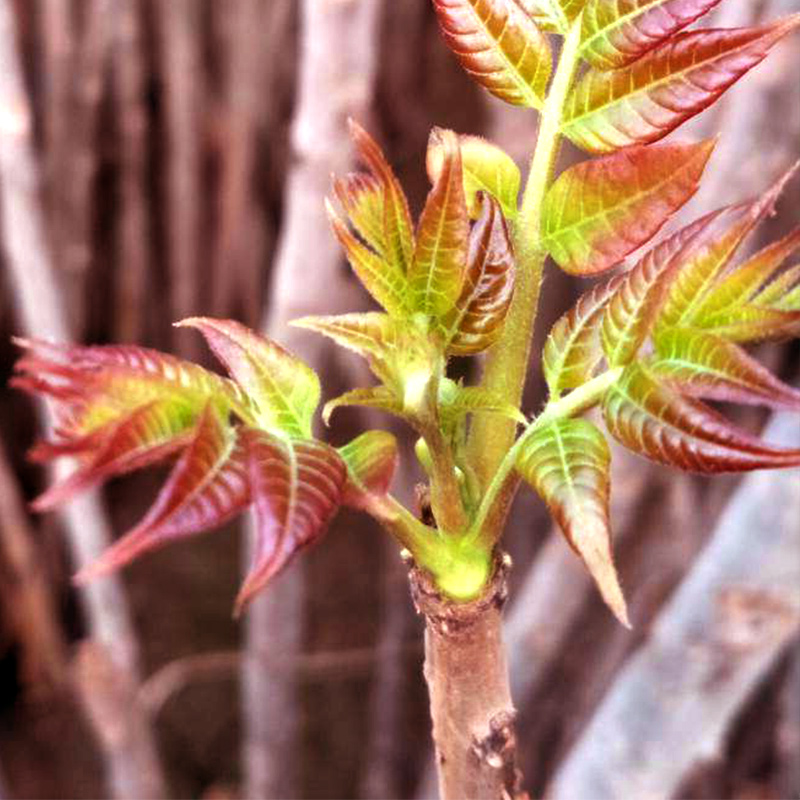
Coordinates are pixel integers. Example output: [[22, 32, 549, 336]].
[[517, 419, 630, 627]]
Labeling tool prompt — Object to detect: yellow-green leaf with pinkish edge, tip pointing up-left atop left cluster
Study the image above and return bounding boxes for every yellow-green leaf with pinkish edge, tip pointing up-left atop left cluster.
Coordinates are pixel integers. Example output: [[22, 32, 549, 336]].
[[177, 317, 320, 436]]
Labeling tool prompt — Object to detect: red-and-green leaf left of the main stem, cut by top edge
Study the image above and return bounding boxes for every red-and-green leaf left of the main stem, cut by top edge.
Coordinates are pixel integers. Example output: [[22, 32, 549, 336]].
[[433, 0, 552, 108]]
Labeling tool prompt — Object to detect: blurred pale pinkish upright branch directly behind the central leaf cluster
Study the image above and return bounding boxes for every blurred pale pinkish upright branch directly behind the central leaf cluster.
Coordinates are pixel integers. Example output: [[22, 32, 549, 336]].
[[243, 0, 382, 798]]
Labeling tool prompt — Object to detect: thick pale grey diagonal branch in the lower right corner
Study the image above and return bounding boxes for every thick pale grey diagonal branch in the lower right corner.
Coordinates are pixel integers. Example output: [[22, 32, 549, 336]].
[[551, 414, 800, 800]]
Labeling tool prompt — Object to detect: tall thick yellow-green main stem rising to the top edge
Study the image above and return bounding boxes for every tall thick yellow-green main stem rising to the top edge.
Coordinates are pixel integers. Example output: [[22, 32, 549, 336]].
[[468, 17, 580, 486]]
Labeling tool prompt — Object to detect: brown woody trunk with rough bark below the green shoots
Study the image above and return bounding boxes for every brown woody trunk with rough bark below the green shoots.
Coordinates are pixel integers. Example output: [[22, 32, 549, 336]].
[[411, 560, 526, 800]]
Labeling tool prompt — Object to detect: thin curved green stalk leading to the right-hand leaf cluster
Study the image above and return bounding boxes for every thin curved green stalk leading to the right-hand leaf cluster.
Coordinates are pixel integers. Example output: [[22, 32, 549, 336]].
[[472, 367, 622, 548]]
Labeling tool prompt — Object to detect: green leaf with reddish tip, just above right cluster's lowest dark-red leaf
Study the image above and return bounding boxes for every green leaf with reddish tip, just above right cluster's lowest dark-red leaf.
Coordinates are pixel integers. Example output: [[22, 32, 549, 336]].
[[651, 328, 800, 409]]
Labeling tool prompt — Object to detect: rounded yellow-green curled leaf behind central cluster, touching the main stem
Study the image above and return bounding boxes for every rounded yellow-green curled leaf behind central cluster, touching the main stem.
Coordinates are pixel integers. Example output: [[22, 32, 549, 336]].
[[426, 134, 521, 219]]
